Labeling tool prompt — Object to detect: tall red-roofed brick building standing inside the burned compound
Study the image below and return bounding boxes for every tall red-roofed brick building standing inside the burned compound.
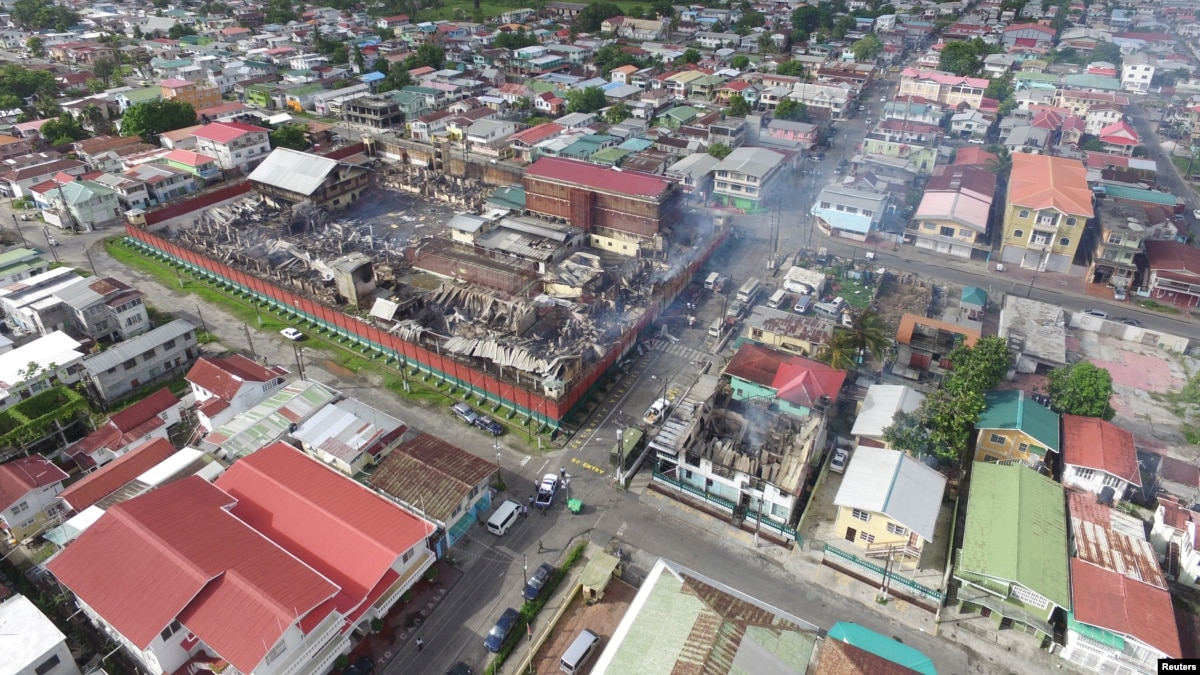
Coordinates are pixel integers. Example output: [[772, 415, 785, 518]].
[[524, 157, 683, 256]]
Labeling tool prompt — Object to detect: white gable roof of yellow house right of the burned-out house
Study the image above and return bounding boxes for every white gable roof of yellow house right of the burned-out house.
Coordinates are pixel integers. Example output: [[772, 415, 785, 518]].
[[833, 446, 946, 542]]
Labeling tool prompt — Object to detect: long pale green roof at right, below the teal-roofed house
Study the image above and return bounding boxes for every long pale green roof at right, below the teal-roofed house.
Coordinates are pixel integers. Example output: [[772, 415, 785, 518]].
[[956, 461, 1070, 609]]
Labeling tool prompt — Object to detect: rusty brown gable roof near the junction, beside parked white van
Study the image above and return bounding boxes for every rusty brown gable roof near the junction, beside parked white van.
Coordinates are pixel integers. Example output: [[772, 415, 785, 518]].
[[368, 434, 496, 522]]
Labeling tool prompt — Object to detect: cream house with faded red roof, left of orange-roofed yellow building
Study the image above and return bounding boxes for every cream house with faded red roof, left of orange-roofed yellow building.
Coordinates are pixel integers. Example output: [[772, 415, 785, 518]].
[[907, 165, 996, 258]]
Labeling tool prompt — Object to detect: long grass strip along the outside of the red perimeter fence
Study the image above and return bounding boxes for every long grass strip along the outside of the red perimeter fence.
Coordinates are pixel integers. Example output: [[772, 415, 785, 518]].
[[106, 238, 552, 452]]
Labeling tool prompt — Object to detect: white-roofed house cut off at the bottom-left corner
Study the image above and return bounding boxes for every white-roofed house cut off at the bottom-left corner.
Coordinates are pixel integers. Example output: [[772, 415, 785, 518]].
[[0, 595, 79, 675]]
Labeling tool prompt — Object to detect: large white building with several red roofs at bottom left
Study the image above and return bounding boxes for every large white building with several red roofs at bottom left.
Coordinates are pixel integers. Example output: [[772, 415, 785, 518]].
[[47, 443, 434, 674]]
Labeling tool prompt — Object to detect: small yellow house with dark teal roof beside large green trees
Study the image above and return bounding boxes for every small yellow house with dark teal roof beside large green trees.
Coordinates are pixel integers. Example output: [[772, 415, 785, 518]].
[[974, 390, 1060, 464]]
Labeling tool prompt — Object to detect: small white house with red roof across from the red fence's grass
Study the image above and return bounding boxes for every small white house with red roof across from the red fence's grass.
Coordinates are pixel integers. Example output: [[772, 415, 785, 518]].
[[186, 354, 288, 432]]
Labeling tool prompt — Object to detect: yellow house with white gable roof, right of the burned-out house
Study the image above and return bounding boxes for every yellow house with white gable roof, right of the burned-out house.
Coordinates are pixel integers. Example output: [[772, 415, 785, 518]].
[[834, 446, 946, 563]]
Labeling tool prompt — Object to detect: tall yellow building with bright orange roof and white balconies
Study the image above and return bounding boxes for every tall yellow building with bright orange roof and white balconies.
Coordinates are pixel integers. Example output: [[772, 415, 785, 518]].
[[1000, 153, 1096, 273]]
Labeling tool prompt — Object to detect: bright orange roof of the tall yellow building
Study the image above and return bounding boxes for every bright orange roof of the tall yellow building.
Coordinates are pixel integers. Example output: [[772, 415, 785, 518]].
[[1008, 153, 1093, 217]]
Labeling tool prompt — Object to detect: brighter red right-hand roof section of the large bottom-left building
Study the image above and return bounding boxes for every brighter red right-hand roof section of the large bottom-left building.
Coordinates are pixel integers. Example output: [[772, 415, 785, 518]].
[[216, 442, 432, 614]]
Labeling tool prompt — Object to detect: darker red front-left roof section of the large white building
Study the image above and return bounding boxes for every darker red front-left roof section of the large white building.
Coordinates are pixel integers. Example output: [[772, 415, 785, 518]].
[[47, 473, 337, 673]]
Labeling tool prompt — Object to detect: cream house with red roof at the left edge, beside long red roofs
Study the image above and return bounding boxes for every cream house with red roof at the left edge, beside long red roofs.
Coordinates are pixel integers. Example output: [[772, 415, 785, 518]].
[[0, 455, 67, 544]]
